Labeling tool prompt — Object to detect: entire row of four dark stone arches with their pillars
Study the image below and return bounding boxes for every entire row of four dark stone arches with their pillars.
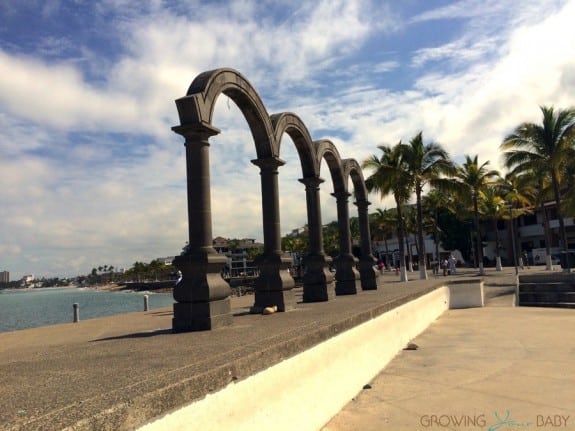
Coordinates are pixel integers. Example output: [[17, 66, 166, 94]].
[[172, 69, 375, 332]]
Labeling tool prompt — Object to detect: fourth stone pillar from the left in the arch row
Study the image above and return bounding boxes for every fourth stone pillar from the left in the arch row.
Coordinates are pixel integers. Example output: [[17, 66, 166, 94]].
[[332, 191, 359, 295]]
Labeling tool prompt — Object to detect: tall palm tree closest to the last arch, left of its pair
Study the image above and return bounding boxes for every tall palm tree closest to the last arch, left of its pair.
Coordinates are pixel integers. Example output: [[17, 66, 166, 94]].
[[362, 141, 413, 281]]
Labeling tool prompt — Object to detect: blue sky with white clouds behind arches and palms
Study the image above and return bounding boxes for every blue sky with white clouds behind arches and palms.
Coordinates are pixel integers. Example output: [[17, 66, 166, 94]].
[[0, 0, 575, 279]]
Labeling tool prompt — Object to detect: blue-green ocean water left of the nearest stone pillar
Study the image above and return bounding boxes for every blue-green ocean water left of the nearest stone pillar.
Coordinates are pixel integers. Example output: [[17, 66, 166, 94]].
[[0, 288, 174, 332]]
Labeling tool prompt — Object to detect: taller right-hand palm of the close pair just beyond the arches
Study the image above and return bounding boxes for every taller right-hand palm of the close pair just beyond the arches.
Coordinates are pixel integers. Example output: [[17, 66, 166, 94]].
[[402, 132, 455, 280]]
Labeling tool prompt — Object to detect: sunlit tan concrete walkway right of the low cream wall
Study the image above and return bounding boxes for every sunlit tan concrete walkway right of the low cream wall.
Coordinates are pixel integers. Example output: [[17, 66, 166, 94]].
[[323, 280, 575, 431]]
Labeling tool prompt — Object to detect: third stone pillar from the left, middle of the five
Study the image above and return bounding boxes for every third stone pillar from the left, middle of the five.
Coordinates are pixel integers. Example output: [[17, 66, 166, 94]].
[[299, 177, 335, 302]]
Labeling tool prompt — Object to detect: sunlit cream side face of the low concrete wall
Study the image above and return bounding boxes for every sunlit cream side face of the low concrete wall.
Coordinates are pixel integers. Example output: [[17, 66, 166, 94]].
[[140, 287, 450, 431]]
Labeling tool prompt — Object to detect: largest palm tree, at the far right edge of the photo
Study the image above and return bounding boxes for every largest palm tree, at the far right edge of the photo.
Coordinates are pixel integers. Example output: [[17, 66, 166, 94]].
[[501, 106, 575, 271]]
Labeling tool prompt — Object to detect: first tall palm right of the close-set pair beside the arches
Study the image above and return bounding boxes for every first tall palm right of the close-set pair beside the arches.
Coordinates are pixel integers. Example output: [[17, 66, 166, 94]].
[[453, 155, 499, 275]]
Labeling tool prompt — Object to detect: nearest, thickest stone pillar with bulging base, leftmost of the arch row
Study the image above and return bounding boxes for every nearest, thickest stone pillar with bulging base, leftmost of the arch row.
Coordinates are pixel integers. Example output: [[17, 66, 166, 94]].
[[172, 126, 232, 332]]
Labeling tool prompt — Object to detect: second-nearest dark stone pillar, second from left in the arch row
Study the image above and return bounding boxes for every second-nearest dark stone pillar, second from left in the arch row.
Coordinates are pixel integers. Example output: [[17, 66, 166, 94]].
[[251, 157, 295, 313]]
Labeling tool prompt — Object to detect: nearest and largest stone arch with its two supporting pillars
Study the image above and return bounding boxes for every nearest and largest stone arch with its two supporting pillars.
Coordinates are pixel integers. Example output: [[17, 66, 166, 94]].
[[172, 69, 296, 332]]
